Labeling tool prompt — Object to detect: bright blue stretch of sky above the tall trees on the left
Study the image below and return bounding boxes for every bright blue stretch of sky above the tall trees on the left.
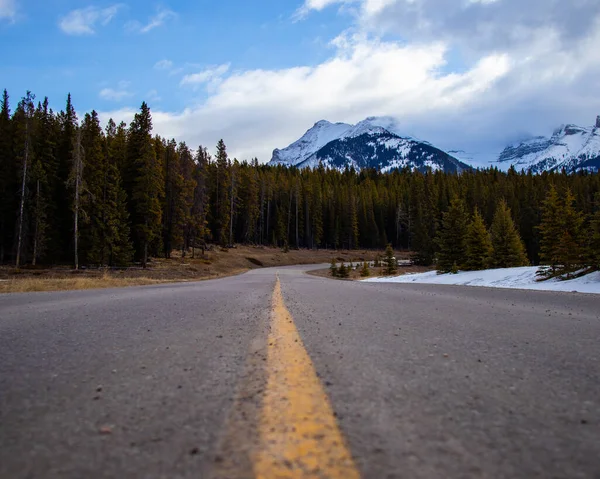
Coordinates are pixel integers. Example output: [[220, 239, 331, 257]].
[[0, 0, 344, 110]]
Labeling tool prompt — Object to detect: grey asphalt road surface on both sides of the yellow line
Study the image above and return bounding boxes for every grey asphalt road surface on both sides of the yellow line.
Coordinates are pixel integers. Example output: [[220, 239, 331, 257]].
[[0, 267, 600, 479]]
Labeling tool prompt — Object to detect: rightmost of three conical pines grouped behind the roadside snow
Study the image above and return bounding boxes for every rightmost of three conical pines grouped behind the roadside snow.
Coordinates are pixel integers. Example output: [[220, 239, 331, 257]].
[[491, 200, 529, 268]]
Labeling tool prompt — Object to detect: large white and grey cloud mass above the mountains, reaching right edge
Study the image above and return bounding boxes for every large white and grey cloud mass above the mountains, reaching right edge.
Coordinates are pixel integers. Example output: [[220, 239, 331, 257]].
[[98, 0, 600, 167]]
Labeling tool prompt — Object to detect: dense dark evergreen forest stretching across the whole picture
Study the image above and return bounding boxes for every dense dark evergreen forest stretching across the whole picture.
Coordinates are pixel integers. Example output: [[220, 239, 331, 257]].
[[0, 91, 600, 274]]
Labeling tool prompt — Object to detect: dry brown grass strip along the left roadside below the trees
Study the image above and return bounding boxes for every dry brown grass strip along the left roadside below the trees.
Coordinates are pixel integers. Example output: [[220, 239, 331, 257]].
[[0, 246, 390, 293]]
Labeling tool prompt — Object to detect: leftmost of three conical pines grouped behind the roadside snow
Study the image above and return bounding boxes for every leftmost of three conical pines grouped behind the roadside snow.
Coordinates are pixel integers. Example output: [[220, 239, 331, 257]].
[[437, 197, 468, 273]]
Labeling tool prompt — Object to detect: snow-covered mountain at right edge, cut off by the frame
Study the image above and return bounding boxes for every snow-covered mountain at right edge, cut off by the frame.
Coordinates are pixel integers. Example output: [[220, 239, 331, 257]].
[[498, 116, 600, 173]]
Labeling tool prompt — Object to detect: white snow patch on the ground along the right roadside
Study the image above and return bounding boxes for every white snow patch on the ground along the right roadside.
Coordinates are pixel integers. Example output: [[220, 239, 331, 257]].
[[364, 266, 600, 294]]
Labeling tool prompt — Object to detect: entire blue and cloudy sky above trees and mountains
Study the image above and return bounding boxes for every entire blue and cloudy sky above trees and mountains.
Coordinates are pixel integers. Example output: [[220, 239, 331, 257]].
[[0, 0, 600, 165]]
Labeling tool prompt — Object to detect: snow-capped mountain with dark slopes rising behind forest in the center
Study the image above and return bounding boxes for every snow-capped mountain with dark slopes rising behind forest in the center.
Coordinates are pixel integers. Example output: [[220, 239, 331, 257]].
[[270, 117, 471, 172]]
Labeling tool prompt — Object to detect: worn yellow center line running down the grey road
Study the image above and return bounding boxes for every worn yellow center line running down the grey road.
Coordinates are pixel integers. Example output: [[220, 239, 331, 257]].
[[253, 278, 360, 479]]
